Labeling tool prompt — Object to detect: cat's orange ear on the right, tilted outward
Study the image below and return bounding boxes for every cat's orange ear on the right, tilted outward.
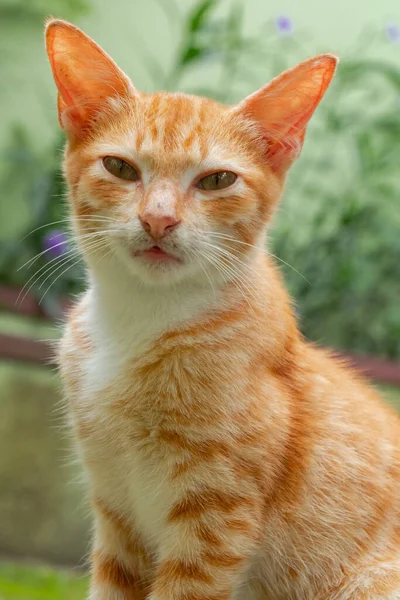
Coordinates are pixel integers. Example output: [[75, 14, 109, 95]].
[[235, 54, 338, 172]]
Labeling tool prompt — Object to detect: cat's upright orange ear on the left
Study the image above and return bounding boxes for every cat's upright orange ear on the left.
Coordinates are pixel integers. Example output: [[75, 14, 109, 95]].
[[46, 19, 137, 138]]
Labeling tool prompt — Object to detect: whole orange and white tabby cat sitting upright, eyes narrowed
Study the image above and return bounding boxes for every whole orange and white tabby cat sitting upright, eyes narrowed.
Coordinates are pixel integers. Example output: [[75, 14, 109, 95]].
[[47, 20, 400, 600]]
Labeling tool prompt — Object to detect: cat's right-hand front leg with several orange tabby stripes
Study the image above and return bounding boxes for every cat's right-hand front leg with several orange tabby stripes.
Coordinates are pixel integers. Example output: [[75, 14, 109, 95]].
[[149, 487, 261, 600]]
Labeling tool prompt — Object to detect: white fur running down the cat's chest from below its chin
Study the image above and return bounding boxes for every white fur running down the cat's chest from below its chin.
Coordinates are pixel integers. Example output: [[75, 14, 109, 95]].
[[68, 278, 222, 545]]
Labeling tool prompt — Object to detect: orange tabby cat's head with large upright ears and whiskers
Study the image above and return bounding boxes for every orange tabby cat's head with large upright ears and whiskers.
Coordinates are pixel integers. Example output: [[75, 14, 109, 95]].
[[46, 20, 337, 284]]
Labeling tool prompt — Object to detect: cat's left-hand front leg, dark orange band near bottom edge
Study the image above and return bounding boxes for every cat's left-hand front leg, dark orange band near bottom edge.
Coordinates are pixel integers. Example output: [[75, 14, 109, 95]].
[[89, 501, 152, 600]]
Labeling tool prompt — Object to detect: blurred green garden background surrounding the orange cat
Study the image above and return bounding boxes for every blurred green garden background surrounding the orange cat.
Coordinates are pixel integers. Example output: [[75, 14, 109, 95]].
[[0, 0, 400, 600]]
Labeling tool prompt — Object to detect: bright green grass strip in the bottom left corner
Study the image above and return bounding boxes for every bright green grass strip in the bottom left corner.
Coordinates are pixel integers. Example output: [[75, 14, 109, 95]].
[[0, 563, 88, 600]]
